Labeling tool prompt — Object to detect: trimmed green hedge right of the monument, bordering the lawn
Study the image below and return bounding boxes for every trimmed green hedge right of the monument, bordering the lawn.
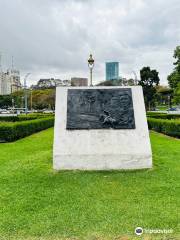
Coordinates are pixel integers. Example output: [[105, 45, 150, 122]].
[[148, 118, 180, 138]]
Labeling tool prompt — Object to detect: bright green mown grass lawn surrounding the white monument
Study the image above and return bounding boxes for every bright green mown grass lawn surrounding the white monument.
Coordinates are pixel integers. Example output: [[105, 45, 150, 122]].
[[0, 129, 180, 240]]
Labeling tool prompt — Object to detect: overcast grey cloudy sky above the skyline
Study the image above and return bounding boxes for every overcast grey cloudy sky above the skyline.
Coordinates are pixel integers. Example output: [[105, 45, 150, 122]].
[[0, 0, 180, 84]]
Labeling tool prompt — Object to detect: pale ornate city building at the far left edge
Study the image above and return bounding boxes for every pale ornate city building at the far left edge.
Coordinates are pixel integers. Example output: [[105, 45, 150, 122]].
[[0, 69, 22, 95]]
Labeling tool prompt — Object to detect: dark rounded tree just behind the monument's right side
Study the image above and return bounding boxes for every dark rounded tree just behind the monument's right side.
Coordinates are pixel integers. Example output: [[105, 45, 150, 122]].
[[138, 67, 160, 110]]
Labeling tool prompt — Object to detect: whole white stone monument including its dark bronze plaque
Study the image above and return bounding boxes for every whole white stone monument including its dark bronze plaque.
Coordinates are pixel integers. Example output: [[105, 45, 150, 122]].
[[53, 86, 152, 170]]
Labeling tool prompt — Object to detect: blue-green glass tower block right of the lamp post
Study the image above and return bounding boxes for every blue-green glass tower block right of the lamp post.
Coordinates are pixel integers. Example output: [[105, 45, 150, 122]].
[[106, 62, 119, 81]]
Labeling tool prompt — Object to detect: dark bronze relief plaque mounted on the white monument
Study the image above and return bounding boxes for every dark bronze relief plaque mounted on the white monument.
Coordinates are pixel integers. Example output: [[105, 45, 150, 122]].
[[66, 88, 135, 130]]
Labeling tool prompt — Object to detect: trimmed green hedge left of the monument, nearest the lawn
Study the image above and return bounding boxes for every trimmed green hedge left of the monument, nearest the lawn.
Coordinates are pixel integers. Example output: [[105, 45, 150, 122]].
[[0, 117, 54, 142]]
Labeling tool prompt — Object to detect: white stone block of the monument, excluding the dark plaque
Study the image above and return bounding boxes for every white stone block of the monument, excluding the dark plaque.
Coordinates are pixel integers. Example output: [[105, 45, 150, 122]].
[[53, 86, 152, 170]]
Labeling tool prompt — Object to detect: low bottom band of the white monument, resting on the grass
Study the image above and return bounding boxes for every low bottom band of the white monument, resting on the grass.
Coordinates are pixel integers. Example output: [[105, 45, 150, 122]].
[[54, 154, 152, 170]]
